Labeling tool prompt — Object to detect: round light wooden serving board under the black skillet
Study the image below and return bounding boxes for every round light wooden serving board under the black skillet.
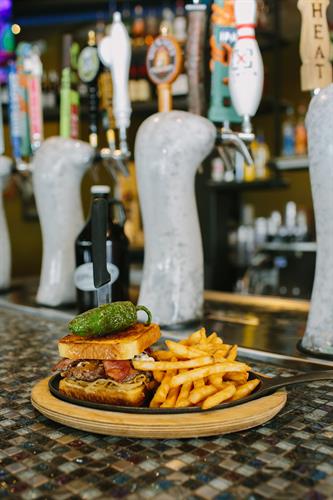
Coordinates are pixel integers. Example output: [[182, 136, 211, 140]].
[[31, 378, 287, 439]]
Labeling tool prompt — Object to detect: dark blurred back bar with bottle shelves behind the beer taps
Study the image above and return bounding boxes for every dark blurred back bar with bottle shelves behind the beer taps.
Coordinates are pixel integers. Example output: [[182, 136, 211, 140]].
[[0, 0, 326, 299]]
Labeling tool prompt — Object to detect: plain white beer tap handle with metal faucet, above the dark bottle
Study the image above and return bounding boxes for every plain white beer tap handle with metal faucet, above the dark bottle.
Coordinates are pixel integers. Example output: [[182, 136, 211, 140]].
[[98, 12, 132, 174]]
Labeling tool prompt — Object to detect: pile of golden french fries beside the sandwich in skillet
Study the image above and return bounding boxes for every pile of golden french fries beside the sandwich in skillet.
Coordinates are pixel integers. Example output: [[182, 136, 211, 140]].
[[133, 328, 259, 410]]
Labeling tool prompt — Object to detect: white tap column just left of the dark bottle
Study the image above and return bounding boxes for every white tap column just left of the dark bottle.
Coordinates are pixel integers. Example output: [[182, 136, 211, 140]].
[[32, 137, 94, 307]]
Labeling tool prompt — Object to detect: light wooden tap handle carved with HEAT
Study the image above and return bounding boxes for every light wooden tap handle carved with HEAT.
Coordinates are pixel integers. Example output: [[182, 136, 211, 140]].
[[297, 0, 332, 90]]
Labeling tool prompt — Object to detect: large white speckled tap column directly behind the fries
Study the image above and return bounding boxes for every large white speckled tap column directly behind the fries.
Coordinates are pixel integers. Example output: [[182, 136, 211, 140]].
[[135, 111, 216, 325]]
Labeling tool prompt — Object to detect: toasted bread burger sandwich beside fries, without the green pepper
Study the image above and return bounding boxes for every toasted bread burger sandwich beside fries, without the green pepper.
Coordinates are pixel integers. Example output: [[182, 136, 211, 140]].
[[54, 323, 161, 406]]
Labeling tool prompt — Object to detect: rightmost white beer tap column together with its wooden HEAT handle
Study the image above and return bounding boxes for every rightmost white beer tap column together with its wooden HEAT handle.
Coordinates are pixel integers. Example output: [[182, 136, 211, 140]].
[[298, 0, 333, 356]]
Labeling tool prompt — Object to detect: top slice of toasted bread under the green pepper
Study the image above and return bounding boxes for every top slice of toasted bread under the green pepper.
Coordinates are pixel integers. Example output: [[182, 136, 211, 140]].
[[58, 323, 161, 360]]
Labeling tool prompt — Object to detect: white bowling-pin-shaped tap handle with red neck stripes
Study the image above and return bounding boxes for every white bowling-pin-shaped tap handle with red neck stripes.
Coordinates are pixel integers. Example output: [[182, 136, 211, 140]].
[[229, 0, 264, 122]]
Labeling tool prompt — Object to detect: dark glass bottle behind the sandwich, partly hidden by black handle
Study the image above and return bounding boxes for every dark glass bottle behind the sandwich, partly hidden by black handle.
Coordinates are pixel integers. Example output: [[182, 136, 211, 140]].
[[74, 185, 129, 312]]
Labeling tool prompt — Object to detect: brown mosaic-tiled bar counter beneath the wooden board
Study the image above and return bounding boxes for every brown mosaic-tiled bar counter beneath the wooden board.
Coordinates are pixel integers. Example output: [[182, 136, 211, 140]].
[[0, 296, 333, 500]]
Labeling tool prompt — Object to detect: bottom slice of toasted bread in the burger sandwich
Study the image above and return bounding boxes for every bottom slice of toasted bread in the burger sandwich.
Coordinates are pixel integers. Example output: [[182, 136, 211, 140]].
[[59, 375, 148, 406]]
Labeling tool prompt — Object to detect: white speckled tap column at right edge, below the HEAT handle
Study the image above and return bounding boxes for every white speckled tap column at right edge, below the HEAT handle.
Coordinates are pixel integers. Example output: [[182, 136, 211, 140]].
[[302, 84, 333, 355]]
